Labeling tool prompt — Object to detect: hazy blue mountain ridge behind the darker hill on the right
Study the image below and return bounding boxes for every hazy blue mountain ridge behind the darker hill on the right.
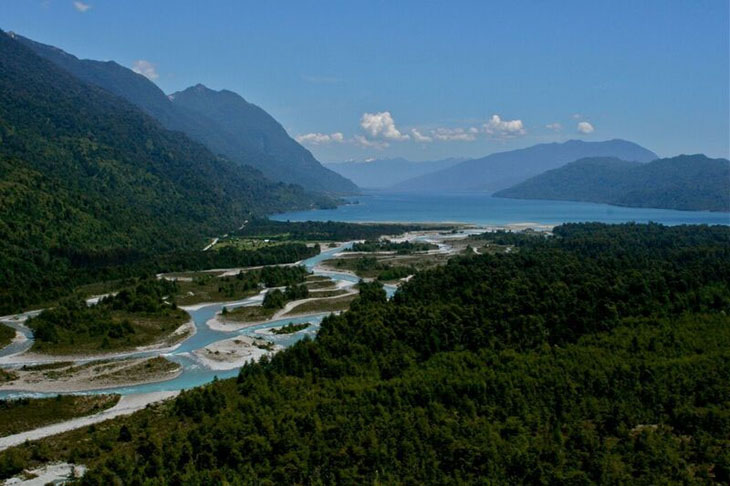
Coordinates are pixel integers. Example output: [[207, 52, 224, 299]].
[[392, 140, 658, 192]]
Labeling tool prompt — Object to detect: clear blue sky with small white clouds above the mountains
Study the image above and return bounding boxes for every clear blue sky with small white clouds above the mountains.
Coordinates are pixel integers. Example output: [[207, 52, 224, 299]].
[[0, 0, 730, 162]]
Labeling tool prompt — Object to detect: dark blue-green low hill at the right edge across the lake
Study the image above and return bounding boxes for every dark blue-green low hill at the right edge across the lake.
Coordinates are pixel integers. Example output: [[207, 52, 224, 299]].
[[495, 155, 730, 211]]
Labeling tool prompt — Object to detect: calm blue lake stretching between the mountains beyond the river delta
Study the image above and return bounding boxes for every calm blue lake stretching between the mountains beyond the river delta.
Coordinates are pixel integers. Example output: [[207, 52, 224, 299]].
[[272, 192, 730, 225]]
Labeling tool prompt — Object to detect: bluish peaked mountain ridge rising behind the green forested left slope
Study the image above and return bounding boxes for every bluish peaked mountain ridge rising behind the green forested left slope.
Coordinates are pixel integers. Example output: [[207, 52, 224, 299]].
[[13, 34, 357, 193]]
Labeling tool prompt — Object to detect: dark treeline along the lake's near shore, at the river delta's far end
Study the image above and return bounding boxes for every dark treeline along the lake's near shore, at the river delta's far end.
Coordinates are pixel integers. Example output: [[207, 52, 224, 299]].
[[234, 218, 453, 241]]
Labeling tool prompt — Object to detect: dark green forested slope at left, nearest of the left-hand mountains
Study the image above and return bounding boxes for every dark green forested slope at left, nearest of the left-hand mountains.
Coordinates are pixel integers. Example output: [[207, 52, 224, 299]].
[[0, 31, 331, 309]]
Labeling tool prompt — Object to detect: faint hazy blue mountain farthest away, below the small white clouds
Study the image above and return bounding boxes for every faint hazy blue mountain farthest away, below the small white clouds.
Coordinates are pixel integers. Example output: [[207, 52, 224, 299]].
[[325, 158, 466, 189]]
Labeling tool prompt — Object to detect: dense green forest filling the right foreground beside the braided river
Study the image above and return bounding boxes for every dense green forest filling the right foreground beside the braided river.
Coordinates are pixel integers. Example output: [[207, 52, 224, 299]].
[[0, 224, 730, 486]]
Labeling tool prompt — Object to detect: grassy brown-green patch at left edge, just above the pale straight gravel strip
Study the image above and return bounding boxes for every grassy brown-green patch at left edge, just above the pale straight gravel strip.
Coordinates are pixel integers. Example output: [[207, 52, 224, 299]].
[[0, 395, 120, 437]]
